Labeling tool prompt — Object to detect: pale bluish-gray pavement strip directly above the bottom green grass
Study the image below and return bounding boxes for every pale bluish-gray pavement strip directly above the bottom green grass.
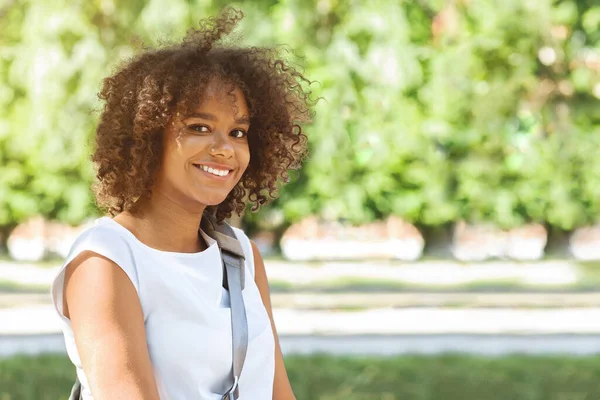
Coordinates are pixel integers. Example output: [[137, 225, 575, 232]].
[[0, 334, 600, 358]]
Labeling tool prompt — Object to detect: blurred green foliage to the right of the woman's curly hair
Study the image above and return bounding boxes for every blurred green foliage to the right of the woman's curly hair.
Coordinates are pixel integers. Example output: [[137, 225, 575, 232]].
[[247, 0, 600, 229]]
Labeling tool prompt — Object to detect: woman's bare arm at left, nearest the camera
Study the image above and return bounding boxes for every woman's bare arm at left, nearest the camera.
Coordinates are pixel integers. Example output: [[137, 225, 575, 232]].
[[64, 251, 159, 400]]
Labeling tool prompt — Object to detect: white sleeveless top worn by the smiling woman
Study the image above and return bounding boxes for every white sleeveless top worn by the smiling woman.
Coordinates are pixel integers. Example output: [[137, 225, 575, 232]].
[[52, 217, 275, 400]]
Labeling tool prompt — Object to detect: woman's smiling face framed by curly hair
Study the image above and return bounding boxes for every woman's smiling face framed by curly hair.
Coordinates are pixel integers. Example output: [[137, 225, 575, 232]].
[[154, 81, 250, 212]]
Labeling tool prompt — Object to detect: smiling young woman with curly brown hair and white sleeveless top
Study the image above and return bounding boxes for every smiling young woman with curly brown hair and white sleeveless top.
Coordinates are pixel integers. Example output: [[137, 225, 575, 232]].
[[52, 10, 310, 400]]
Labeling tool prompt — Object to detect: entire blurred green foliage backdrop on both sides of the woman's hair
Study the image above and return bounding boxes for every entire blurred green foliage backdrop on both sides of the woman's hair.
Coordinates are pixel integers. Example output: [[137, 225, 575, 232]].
[[0, 0, 600, 234]]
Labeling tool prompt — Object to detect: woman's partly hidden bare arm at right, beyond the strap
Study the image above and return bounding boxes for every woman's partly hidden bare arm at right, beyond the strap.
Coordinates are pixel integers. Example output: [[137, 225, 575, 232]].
[[251, 241, 296, 400]]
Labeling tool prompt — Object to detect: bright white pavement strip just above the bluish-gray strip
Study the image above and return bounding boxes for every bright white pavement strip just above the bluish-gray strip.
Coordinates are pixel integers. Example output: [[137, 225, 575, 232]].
[[0, 305, 600, 335]]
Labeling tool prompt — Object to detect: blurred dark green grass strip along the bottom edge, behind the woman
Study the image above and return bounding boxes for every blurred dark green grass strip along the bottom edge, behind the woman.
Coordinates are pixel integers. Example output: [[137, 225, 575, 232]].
[[0, 354, 600, 400]]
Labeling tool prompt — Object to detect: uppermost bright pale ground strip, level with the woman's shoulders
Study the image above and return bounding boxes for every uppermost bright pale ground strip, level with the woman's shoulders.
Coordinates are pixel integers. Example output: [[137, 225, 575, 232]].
[[0, 260, 579, 287]]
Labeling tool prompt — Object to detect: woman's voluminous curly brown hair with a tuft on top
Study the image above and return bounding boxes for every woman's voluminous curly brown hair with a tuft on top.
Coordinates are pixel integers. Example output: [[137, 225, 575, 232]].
[[92, 8, 313, 221]]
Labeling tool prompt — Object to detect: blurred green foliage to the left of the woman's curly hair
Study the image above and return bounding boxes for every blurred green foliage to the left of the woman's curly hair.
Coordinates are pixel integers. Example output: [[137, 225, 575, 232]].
[[0, 0, 221, 231]]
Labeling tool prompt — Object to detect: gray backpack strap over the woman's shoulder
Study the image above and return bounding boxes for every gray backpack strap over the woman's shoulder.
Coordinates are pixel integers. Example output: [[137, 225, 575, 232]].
[[200, 216, 248, 400]]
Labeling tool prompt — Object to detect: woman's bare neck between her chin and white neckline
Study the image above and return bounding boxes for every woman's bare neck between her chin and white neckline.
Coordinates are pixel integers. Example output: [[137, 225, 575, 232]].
[[114, 191, 206, 253]]
